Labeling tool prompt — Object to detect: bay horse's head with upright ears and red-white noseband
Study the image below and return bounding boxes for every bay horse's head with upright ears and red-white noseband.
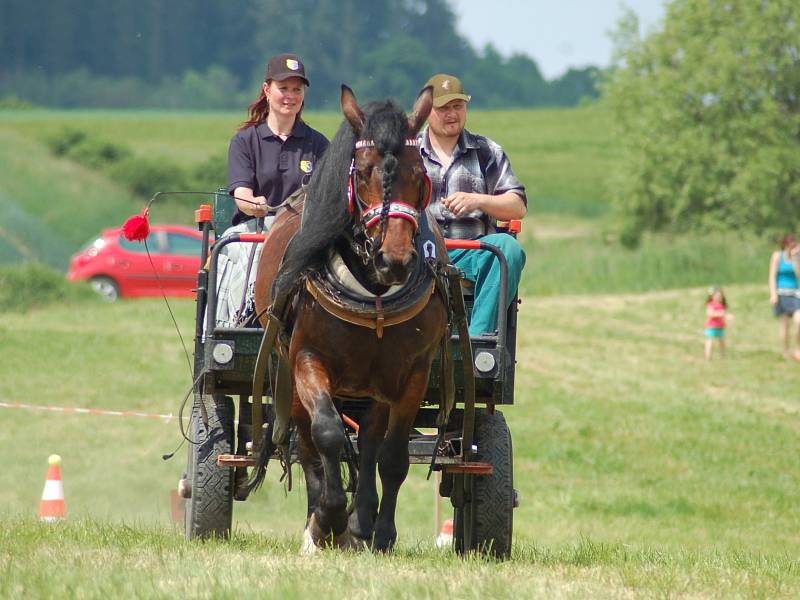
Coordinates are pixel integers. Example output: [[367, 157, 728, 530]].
[[341, 85, 433, 286]]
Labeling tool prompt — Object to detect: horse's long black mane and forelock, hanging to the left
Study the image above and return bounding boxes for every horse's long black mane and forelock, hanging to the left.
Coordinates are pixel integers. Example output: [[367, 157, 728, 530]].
[[272, 100, 408, 298]]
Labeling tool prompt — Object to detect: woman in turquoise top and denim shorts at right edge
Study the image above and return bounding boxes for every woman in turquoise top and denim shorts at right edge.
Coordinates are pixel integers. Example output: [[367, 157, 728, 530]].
[[769, 234, 800, 360]]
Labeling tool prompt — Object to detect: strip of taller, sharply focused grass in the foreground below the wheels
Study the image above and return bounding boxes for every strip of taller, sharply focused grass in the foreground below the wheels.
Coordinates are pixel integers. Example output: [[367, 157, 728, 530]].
[[0, 520, 797, 600]]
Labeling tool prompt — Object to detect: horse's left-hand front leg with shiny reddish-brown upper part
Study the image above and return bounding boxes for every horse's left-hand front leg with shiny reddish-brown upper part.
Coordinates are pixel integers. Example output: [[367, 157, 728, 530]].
[[294, 351, 350, 546]]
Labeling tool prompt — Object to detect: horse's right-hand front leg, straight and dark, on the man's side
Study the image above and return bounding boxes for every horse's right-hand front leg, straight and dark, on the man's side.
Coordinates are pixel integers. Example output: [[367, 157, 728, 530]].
[[373, 369, 428, 551]]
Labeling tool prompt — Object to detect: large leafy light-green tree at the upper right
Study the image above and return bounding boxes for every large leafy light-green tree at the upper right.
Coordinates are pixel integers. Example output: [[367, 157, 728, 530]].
[[607, 0, 800, 244]]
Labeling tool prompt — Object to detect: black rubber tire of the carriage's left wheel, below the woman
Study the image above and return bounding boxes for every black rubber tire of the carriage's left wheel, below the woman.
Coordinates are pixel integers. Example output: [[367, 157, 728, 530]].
[[184, 395, 234, 540]]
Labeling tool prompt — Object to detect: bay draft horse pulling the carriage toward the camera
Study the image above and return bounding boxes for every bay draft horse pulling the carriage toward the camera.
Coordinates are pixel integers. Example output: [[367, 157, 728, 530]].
[[256, 86, 448, 552]]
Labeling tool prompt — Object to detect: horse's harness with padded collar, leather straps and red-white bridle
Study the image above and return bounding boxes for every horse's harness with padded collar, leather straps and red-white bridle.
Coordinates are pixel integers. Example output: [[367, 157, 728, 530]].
[[251, 138, 466, 468]]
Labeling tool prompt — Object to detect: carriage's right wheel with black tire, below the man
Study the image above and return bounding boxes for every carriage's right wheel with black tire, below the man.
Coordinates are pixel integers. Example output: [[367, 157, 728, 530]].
[[453, 410, 514, 558]]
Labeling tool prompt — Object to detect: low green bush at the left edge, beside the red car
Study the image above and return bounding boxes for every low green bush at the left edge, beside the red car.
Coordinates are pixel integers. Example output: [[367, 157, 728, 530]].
[[0, 262, 98, 312]]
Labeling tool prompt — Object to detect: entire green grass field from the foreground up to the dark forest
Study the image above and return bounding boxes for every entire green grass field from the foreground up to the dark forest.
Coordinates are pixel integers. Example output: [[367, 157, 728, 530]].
[[0, 107, 800, 598]]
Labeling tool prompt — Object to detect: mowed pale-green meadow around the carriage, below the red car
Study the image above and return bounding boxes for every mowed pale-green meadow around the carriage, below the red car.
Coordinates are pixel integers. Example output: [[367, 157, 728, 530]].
[[0, 283, 800, 598]]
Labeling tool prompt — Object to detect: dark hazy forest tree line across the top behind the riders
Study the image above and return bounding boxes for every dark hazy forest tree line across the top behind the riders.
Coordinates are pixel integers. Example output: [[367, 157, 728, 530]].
[[0, 0, 598, 108]]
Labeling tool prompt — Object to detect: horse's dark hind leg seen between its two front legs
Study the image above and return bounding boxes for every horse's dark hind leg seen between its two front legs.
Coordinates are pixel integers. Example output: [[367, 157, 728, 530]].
[[350, 402, 389, 544]]
